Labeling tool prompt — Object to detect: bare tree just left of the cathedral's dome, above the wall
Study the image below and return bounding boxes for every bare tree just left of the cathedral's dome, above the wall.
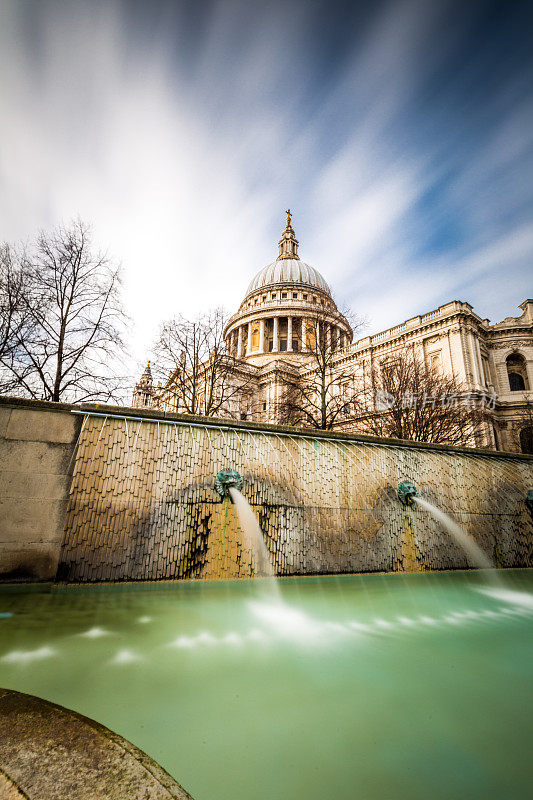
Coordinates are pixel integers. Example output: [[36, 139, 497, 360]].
[[154, 308, 249, 416]]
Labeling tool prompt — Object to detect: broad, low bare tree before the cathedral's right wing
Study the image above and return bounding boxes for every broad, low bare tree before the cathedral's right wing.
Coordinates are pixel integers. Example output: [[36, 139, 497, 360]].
[[355, 348, 495, 446]]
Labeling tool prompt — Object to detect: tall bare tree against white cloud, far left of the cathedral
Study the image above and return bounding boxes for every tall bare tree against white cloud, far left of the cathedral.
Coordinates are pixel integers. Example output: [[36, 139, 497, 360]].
[[1, 220, 125, 402]]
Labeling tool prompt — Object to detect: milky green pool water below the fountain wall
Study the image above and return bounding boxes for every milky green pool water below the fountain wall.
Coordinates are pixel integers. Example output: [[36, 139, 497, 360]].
[[0, 570, 533, 800]]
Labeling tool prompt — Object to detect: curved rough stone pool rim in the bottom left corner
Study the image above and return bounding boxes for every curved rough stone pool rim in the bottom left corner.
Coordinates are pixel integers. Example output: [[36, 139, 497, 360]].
[[0, 689, 192, 800]]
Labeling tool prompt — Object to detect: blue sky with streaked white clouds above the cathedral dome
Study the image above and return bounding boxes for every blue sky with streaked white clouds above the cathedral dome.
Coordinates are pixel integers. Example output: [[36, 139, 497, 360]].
[[0, 0, 533, 360]]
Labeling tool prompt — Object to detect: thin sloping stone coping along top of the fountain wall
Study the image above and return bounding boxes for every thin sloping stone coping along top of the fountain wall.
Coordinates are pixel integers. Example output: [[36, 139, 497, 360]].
[[0, 397, 533, 462]]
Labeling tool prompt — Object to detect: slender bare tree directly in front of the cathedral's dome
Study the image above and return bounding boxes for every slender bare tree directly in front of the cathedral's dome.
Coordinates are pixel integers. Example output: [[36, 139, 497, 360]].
[[278, 314, 361, 430]]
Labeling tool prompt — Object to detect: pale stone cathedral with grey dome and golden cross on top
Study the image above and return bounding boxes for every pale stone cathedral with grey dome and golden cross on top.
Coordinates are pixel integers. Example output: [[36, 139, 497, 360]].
[[133, 212, 533, 452]]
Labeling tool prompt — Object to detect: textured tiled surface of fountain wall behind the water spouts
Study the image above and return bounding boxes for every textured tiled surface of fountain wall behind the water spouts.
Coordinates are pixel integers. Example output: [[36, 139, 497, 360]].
[[58, 416, 533, 581]]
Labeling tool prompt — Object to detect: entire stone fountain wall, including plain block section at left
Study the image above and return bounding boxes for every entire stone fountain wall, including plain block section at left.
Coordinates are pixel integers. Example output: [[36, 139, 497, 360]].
[[0, 399, 533, 581]]
